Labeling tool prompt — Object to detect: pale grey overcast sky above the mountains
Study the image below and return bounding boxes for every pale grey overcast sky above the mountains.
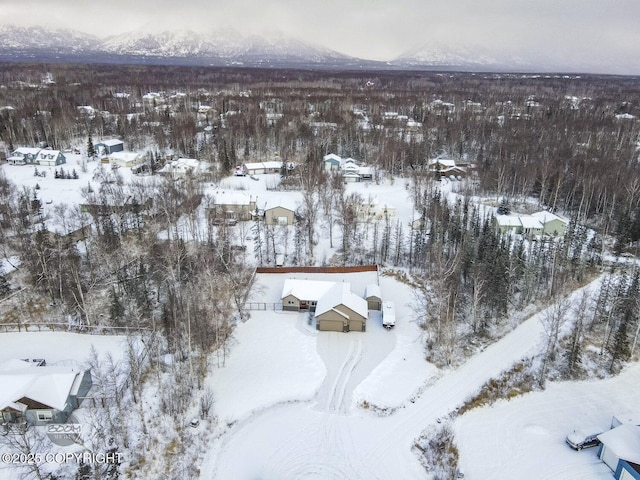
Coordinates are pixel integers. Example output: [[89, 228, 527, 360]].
[[0, 0, 640, 73]]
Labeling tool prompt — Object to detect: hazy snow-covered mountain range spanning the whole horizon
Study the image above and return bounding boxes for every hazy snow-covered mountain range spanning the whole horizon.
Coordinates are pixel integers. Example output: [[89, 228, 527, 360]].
[[0, 25, 640, 73]]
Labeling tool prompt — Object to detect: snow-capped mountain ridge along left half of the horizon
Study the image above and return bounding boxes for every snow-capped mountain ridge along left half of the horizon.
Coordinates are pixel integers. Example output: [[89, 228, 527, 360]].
[[0, 26, 357, 66]]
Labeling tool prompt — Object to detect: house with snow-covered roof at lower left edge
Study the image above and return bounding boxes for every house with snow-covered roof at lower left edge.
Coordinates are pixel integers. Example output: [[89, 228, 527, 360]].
[[0, 359, 92, 425]]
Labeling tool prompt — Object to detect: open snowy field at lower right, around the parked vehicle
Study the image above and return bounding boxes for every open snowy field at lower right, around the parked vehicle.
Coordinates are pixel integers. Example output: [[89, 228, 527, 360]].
[[455, 365, 640, 480]]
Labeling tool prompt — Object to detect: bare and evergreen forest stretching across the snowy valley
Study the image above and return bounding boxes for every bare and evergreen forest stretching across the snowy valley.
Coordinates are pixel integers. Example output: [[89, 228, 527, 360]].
[[0, 63, 640, 478]]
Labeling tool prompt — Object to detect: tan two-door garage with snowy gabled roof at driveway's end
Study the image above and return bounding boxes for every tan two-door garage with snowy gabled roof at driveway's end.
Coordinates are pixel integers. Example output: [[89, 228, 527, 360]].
[[316, 283, 368, 332]]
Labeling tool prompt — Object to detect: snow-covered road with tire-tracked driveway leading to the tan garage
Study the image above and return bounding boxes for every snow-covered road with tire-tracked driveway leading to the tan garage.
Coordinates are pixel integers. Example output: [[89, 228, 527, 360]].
[[202, 280, 608, 480]]
